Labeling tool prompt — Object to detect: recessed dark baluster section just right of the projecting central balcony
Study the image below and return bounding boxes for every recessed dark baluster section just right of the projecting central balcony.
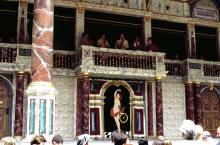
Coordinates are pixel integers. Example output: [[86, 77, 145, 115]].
[[165, 60, 186, 76]]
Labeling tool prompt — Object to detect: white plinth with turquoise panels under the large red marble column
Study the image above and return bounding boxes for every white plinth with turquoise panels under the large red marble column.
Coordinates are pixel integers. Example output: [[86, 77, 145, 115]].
[[26, 82, 56, 138]]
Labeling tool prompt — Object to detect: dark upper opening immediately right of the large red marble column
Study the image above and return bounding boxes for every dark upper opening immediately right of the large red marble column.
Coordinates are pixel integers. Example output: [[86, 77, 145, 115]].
[[53, 7, 76, 51]]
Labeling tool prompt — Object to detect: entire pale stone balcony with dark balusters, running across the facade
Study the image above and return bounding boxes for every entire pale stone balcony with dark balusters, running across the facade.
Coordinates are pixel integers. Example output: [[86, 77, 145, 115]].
[[0, 43, 220, 83]]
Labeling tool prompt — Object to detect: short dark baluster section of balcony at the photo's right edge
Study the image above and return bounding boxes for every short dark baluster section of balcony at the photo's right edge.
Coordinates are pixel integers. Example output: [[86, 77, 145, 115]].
[[203, 64, 220, 77]]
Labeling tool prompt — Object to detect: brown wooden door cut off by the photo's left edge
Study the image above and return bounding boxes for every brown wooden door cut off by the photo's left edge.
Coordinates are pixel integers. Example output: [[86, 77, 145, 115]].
[[0, 83, 9, 138]]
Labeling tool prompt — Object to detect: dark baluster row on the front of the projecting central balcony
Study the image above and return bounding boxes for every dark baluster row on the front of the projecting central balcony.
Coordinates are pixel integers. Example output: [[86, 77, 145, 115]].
[[93, 51, 156, 69]]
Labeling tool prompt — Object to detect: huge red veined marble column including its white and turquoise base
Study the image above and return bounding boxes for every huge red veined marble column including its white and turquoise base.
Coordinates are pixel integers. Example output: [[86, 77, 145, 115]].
[[26, 0, 56, 138]]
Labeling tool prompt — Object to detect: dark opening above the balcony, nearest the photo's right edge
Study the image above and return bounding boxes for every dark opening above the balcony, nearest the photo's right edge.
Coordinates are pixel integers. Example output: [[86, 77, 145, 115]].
[[195, 26, 218, 61]]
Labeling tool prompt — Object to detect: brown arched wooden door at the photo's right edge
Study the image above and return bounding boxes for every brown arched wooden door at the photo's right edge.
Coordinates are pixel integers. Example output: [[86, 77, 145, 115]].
[[203, 91, 220, 137]]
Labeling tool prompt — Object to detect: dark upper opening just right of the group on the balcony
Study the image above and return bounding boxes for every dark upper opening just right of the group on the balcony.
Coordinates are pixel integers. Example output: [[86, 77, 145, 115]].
[[152, 20, 187, 60]]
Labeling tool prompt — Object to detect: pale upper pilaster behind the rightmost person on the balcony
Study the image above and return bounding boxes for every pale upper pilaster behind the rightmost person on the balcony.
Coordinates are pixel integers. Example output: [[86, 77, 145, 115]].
[[143, 17, 152, 44]]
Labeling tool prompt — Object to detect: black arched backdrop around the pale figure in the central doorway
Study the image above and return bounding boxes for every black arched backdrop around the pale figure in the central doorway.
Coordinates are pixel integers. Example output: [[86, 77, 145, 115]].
[[104, 85, 130, 132]]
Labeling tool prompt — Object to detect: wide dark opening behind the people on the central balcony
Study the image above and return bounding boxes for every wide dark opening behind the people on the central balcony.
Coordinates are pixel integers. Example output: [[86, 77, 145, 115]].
[[85, 11, 144, 50]]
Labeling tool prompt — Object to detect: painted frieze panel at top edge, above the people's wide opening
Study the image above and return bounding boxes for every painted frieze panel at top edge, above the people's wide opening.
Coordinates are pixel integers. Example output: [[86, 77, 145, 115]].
[[80, 0, 146, 10]]
